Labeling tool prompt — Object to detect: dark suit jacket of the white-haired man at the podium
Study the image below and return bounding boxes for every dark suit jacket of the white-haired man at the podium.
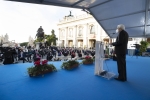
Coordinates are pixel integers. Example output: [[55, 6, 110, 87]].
[[112, 30, 129, 54]]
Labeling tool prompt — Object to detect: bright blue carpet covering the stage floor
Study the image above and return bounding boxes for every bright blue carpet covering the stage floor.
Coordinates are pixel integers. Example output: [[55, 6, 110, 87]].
[[0, 56, 150, 100]]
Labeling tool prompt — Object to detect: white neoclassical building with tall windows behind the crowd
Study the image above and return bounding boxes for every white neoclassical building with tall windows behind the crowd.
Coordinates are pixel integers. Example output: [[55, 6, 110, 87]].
[[57, 14, 109, 48]]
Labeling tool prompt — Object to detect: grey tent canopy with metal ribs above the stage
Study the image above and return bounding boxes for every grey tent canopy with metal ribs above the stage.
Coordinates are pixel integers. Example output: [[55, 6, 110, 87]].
[[5, 0, 150, 37]]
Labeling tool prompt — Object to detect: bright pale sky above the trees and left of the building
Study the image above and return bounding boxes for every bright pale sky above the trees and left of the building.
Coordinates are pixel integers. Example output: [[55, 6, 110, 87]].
[[0, 0, 84, 42]]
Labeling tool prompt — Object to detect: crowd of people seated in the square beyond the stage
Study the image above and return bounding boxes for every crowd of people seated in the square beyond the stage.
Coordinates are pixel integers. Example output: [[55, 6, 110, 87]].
[[0, 46, 95, 64]]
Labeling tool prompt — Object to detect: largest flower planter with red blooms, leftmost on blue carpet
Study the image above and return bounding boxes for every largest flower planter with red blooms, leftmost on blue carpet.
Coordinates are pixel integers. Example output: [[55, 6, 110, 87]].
[[28, 60, 57, 77]]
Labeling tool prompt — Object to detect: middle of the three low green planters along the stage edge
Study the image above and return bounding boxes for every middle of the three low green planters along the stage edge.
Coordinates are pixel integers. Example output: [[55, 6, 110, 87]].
[[61, 60, 79, 70]]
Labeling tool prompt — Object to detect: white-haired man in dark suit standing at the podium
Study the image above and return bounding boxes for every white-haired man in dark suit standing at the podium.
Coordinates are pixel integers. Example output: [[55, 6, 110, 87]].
[[112, 24, 129, 81]]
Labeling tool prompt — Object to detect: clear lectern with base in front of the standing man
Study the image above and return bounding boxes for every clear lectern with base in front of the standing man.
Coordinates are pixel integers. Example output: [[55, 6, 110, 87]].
[[94, 41, 115, 79]]
